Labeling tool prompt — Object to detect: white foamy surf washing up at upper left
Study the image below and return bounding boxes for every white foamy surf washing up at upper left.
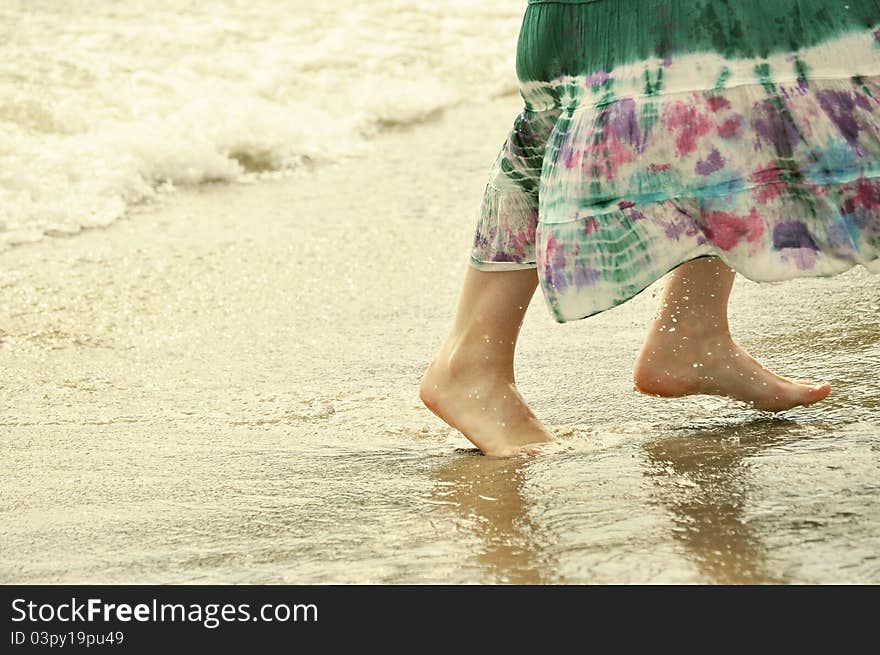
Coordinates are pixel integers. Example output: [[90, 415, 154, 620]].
[[0, 0, 524, 249]]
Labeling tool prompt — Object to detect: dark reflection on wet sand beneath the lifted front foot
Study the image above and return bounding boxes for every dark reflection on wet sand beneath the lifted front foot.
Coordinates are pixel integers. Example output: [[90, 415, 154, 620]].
[[644, 417, 799, 584]]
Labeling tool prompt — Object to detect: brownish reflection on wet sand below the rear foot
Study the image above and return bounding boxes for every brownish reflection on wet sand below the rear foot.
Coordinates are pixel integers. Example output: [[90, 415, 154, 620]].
[[431, 450, 555, 584]]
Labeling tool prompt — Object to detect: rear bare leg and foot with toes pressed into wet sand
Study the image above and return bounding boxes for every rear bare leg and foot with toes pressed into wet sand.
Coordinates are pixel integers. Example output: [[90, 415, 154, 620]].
[[420, 266, 553, 457]]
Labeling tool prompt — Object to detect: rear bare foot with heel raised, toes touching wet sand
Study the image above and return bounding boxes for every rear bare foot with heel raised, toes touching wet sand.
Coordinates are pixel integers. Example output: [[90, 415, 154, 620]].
[[419, 351, 554, 457]]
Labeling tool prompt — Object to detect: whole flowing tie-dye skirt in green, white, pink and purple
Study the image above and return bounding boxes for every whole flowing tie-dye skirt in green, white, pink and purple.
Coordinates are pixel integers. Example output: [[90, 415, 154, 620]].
[[470, 0, 880, 323]]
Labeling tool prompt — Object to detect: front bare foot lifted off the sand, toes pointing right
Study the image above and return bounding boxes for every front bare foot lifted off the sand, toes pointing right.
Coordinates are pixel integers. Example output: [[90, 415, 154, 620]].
[[633, 331, 831, 412]]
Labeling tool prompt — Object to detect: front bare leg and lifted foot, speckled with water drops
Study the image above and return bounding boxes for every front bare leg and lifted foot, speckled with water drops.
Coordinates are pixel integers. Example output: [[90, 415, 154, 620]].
[[633, 257, 831, 411]]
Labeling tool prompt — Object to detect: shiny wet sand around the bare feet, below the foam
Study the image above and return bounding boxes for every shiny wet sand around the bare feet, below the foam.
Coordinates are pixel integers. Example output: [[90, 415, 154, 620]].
[[0, 97, 880, 583]]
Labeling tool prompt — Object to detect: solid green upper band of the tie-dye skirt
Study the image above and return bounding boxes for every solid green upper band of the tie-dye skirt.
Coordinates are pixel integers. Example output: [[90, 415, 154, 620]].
[[517, 0, 880, 81]]
